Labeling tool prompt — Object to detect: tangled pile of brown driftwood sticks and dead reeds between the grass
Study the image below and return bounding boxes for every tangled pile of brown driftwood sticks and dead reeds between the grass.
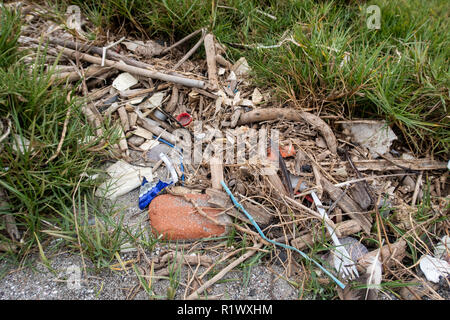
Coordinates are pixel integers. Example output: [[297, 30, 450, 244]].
[[0, 1, 449, 299]]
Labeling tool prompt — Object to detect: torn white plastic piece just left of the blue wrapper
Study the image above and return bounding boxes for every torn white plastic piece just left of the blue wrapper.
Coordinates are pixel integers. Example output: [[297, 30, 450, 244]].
[[95, 160, 153, 200]]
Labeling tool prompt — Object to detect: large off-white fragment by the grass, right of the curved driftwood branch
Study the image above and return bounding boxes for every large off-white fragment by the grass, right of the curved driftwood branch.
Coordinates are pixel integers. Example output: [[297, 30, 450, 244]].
[[343, 120, 397, 158]]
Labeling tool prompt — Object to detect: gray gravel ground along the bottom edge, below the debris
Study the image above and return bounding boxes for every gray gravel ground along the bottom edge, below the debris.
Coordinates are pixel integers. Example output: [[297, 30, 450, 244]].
[[0, 178, 298, 300]]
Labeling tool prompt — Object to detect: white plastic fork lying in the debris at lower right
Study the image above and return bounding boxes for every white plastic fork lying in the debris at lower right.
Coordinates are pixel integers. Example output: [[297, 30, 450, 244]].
[[311, 192, 359, 280]]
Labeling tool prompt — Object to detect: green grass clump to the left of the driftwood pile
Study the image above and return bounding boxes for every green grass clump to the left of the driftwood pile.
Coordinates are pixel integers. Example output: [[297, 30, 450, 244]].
[[0, 5, 133, 268]]
